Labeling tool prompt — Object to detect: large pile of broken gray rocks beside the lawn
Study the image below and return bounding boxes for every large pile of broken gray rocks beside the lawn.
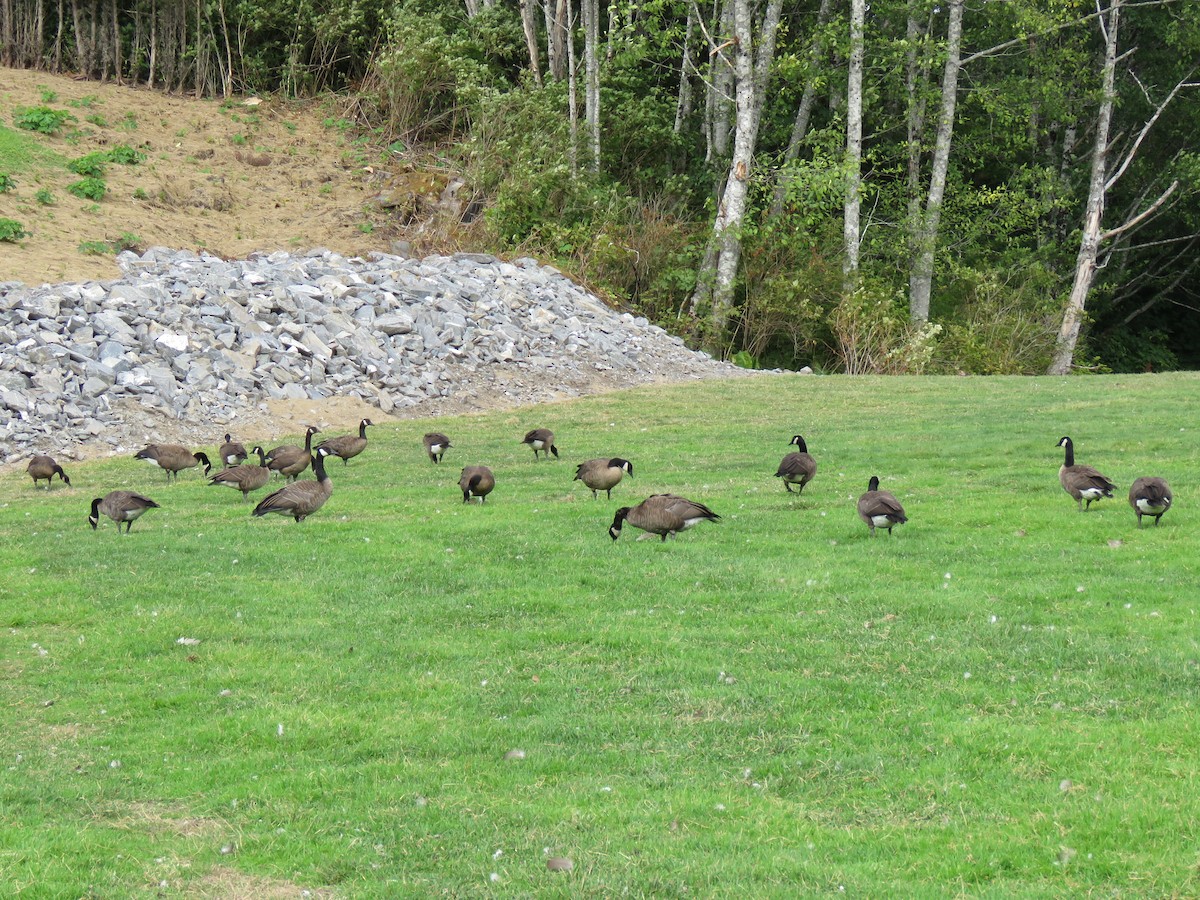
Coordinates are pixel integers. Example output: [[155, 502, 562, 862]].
[[0, 247, 738, 462]]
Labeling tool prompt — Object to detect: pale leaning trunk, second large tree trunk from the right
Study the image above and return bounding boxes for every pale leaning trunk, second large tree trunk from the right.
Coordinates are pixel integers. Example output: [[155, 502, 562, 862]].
[[908, 0, 964, 322]]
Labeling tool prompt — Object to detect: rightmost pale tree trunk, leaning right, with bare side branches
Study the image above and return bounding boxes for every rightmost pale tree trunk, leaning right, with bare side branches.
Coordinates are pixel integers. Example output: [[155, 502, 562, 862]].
[[1046, 0, 1122, 374]]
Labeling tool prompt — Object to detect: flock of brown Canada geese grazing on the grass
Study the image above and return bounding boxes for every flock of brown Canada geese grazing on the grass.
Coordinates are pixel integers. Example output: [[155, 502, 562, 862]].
[[26, 427, 1174, 541]]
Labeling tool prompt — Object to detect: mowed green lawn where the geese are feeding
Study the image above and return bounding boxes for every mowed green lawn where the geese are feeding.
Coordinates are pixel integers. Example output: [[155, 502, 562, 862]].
[[0, 374, 1200, 898]]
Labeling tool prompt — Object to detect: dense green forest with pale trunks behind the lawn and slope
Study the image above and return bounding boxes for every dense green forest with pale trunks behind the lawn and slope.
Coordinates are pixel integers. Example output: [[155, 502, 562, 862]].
[[0, 0, 1200, 373]]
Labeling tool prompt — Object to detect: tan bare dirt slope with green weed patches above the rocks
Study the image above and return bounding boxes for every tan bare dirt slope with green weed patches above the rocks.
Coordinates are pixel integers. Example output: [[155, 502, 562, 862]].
[[0, 68, 403, 284]]
